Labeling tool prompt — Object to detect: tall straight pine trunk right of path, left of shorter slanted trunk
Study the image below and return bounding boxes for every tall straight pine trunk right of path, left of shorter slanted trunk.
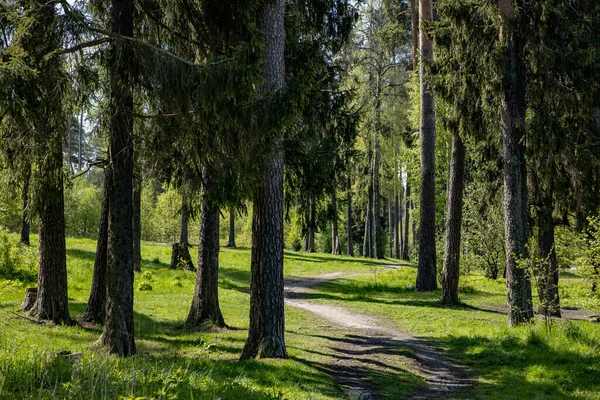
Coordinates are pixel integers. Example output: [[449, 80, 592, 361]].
[[416, 0, 437, 292]]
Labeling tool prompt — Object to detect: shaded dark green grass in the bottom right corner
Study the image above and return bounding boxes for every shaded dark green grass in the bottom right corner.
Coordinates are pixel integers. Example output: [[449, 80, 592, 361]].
[[440, 336, 600, 399]]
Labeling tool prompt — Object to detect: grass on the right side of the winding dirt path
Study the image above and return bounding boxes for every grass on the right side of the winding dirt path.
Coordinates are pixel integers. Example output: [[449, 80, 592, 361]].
[[313, 268, 600, 399]]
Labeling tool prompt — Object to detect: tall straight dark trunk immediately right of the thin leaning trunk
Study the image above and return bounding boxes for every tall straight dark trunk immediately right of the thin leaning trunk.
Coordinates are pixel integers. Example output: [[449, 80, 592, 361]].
[[100, 0, 136, 356]]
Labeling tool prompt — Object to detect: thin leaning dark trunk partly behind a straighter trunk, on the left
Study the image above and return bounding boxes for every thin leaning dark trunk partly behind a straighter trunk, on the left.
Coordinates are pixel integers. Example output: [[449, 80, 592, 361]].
[[81, 170, 110, 324]]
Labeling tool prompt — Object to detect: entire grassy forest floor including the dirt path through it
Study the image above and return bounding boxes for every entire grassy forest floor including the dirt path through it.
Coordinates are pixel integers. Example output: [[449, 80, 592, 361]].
[[0, 236, 600, 400]]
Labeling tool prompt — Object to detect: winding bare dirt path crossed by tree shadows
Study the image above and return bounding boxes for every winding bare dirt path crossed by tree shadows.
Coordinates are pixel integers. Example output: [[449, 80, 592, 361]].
[[285, 265, 471, 400]]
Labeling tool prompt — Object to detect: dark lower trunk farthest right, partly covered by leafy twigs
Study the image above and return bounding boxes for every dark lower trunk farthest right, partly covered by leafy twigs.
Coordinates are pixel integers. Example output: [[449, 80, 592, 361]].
[[538, 189, 561, 318]]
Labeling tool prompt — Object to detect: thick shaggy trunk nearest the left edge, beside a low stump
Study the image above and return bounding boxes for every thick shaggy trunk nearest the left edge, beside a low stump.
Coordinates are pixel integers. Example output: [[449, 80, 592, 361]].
[[23, 0, 72, 324]]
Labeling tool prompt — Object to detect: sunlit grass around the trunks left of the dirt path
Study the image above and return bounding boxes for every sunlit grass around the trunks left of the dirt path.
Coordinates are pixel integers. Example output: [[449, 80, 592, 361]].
[[0, 235, 415, 399]]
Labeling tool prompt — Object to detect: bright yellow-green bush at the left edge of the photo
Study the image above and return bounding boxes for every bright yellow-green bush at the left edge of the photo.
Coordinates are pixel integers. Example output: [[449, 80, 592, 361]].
[[0, 228, 37, 283]]
